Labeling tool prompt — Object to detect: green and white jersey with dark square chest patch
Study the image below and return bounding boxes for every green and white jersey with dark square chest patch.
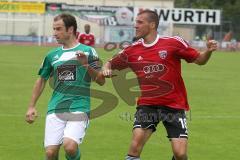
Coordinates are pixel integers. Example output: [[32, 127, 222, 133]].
[[38, 44, 99, 114]]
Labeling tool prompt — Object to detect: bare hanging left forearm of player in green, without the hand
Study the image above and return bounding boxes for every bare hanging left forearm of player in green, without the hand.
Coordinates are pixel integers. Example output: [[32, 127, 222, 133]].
[[29, 78, 46, 107]]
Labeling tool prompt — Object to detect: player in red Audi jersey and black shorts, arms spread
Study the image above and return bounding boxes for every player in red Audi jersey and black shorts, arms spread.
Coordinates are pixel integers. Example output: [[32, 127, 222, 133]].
[[103, 10, 217, 160]]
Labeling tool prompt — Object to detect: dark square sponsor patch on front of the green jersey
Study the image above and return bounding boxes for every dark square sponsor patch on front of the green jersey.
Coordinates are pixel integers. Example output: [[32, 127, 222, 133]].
[[57, 65, 76, 81]]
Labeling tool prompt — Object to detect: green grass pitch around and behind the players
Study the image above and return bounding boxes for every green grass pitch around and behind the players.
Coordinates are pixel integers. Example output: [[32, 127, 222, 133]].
[[0, 45, 240, 160]]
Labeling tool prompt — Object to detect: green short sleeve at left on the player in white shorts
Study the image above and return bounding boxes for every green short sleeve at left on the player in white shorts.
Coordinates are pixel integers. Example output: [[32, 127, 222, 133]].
[[38, 56, 53, 80]]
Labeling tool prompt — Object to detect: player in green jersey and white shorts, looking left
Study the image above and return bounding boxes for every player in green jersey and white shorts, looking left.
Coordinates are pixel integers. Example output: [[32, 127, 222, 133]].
[[26, 14, 105, 160]]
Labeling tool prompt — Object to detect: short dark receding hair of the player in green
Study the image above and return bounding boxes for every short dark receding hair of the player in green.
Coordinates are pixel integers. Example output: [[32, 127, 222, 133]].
[[53, 13, 77, 35]]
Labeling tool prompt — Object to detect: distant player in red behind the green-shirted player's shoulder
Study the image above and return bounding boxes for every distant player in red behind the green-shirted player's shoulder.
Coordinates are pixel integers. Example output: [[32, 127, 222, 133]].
[[77, 24, 95, 47]]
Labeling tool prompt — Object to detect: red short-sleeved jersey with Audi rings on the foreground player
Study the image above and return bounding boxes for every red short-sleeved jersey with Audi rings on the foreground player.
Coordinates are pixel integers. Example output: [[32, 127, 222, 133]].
[[109, 35, 199, 110]]
